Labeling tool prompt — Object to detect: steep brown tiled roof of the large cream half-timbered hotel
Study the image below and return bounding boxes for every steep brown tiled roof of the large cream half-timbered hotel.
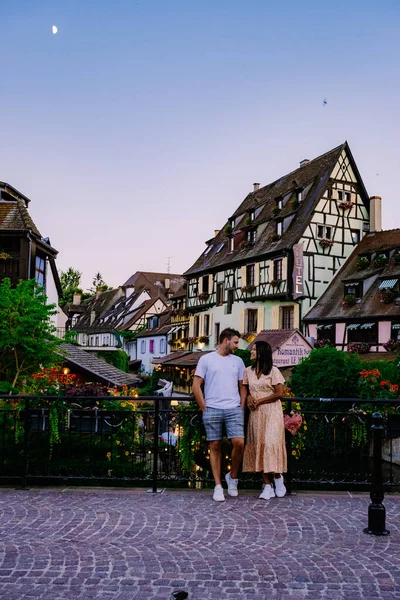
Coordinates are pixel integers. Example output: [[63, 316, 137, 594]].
[[184, 142, 369, 277]]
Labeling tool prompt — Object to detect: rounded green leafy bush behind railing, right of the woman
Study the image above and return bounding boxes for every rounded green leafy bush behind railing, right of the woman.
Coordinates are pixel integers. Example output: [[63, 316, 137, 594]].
[[289, 346, 362, 398]]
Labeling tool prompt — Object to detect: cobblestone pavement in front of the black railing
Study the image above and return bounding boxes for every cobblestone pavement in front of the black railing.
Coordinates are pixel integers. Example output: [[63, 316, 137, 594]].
[[0, 489, 400, 600]]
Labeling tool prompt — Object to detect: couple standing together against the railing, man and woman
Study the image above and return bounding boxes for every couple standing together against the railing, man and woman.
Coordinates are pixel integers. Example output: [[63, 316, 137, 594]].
[[193, 328, 286, 502]]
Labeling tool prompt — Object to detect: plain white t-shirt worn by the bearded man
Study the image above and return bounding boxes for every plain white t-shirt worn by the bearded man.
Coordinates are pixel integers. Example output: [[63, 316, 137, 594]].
[[195, 352, 245, 408]]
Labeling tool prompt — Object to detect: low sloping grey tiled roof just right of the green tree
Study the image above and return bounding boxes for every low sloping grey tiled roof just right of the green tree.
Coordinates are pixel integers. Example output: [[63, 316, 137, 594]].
[[60, 343, 140, 386]]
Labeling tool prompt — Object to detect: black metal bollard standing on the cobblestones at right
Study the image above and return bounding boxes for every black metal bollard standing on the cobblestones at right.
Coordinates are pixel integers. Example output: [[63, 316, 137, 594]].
[[364, 413, 390, 536]]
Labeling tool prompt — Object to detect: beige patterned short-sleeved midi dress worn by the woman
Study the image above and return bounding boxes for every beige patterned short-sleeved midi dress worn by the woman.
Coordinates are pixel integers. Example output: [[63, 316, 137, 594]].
[[243, 367, 287, 473]]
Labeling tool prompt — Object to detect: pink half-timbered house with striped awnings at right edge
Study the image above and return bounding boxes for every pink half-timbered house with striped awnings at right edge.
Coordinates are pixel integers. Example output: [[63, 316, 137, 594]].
[[304, 229, 400, 352]]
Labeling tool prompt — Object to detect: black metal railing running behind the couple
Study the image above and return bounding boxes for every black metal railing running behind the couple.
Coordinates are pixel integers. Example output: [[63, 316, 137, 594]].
[[0, 395, 400, 492]]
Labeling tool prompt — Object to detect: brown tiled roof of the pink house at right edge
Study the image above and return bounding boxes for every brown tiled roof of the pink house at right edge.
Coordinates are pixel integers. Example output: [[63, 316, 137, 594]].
[[304, 229, 400, 322]]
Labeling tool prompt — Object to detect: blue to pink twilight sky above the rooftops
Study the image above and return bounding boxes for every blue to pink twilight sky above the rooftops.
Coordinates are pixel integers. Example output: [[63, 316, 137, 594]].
[[0, 0, 400, 287]]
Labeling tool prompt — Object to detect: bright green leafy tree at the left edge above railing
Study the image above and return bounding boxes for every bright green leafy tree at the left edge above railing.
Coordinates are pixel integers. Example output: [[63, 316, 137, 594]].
[[0, 278, 60, 393]]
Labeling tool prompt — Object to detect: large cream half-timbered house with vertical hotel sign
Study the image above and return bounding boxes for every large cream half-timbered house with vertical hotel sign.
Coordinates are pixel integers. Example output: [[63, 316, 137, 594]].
[[184, 142, 370, 349]]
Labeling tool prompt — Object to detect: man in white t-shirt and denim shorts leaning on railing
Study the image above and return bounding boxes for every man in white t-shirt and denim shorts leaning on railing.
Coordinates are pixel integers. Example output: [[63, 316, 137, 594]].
[[193, 328, 246, 502]]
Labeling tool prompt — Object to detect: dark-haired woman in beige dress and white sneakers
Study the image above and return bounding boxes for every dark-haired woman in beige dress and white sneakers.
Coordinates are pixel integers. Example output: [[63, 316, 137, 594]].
[[243, 342, 287, 500]]
